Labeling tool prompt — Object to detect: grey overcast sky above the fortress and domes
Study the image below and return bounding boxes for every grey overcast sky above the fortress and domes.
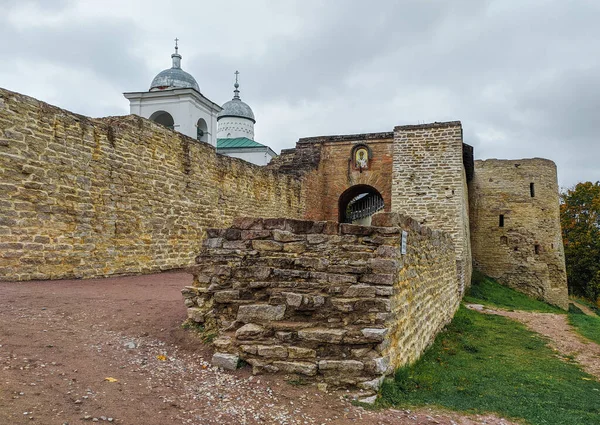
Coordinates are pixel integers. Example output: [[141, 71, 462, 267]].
[[0, 0, 600, 186]]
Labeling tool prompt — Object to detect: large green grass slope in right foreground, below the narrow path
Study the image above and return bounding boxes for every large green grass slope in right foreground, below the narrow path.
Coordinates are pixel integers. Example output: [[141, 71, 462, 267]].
[[379, 306, 600, 425]]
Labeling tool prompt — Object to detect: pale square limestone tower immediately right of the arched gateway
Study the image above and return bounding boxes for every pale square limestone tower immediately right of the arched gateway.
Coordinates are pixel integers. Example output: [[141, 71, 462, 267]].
[[392, 121, 471, 293]]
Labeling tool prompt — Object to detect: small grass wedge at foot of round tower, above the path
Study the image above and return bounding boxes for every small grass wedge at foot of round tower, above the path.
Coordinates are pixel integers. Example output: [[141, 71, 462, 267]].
[[464, 270, 565, 313]]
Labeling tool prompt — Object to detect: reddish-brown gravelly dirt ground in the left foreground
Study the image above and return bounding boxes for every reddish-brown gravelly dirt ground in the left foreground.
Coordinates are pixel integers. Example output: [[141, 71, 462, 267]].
[[0, 273, 512, 425]]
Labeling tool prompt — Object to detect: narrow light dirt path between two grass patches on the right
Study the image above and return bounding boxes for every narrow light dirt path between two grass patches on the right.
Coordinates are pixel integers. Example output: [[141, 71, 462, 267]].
[[467, 304, 600, 380]]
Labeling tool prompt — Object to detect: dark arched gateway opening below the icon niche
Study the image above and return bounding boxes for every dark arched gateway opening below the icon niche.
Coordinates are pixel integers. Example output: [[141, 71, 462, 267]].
[[338, 184, 385, 226]]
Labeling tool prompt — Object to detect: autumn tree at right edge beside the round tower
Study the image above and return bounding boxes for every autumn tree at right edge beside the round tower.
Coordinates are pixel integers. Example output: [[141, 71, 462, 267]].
[[560, 182, 600, 302]]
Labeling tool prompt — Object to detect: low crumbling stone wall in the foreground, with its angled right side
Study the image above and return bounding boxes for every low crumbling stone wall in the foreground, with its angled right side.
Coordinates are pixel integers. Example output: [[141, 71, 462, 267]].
[[182, 213, 461, 390]]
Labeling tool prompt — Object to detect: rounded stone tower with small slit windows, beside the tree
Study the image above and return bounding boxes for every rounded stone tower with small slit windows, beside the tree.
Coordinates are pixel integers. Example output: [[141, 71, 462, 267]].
[[470, 158, 568, 309]]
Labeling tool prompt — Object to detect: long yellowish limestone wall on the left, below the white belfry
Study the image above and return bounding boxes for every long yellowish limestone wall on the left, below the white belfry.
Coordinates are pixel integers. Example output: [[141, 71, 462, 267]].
[[0, 89, 304, 280]]
